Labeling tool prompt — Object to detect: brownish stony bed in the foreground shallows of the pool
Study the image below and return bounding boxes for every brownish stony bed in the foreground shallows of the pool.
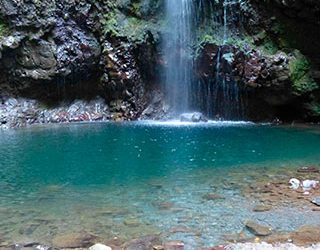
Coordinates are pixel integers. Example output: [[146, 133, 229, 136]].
[[0, 163, 320, 250]]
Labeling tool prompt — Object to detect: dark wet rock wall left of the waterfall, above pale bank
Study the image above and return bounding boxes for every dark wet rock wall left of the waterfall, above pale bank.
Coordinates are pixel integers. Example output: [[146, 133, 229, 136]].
[[0, 0, 159, 119]]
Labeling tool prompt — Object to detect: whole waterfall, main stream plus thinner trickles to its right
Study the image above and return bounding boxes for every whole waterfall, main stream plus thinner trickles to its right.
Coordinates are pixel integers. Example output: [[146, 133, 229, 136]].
[[163, 0, 243, 119]]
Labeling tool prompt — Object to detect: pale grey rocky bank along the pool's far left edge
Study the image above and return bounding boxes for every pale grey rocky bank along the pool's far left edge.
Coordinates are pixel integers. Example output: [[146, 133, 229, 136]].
[[0, 98, 113, 129]]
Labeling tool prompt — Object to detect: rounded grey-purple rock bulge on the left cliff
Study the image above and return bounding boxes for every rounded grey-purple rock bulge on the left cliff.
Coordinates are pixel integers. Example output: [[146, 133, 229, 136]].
[[3, 18, 101, 82]]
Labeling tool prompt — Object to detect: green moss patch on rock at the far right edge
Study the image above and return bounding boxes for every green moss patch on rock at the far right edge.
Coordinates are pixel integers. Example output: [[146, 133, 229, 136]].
[[289, 51, 319, 95]]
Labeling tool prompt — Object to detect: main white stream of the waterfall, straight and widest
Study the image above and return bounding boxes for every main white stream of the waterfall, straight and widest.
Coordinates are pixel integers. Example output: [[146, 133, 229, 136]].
[[163, 0, 193, 114]]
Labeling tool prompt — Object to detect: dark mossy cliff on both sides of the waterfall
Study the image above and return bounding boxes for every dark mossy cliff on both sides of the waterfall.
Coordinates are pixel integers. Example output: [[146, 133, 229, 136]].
[[0, 0, 320, 125]]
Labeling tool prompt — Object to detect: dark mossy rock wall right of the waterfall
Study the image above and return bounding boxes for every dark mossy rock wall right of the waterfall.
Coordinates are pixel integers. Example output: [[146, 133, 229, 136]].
[[192, 0, 320, 121]]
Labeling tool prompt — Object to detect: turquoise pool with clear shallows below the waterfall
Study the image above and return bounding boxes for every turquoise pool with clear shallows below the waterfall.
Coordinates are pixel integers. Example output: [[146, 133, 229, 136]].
[[0, 122, 320, 249]]
